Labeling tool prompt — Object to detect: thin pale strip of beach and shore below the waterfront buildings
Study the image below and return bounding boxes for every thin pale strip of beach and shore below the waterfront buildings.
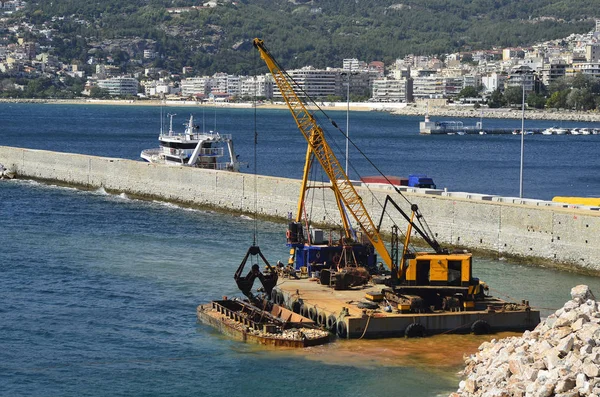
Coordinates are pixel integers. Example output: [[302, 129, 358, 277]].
[[0, 98, 600, 122]]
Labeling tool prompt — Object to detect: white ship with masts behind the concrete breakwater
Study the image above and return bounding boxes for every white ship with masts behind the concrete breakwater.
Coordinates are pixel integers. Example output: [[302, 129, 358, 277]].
[[140, 114, 240, 171]]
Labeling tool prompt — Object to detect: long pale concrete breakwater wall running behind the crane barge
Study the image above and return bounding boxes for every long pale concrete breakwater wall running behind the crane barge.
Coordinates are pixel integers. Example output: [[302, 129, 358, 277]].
[[0, 146, 600, 272]]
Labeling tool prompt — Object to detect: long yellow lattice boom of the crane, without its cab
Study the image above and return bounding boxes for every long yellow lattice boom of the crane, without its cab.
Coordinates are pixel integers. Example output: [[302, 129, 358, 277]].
[[254, 39, 392, 269]]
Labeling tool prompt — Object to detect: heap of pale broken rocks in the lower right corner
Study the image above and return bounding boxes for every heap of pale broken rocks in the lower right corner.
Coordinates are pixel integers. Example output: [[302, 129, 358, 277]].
[[450, 285, 600, 397]]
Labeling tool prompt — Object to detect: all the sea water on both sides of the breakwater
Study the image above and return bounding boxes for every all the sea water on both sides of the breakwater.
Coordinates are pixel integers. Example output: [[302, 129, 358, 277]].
[[0, 104, 600, 397]]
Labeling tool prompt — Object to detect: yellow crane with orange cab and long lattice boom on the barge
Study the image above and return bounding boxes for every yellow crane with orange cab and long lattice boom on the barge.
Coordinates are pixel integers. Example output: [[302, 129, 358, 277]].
[[253, 38, 485, 311]]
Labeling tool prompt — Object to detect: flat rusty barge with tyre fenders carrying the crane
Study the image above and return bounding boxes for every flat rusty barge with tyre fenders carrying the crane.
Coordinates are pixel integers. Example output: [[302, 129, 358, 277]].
[[273, 278, 540, 339]]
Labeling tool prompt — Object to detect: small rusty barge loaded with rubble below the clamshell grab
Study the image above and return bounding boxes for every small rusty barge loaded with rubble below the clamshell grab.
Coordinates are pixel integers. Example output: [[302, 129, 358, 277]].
[[196, 299, 329, 347]]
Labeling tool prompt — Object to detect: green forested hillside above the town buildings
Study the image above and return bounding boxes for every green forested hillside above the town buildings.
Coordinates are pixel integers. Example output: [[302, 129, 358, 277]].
[[25, 0, 600, 74]]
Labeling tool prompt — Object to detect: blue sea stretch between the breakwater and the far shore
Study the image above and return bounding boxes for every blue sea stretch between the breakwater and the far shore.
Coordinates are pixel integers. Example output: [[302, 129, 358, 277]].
[[0, 103, 600, 200]]
